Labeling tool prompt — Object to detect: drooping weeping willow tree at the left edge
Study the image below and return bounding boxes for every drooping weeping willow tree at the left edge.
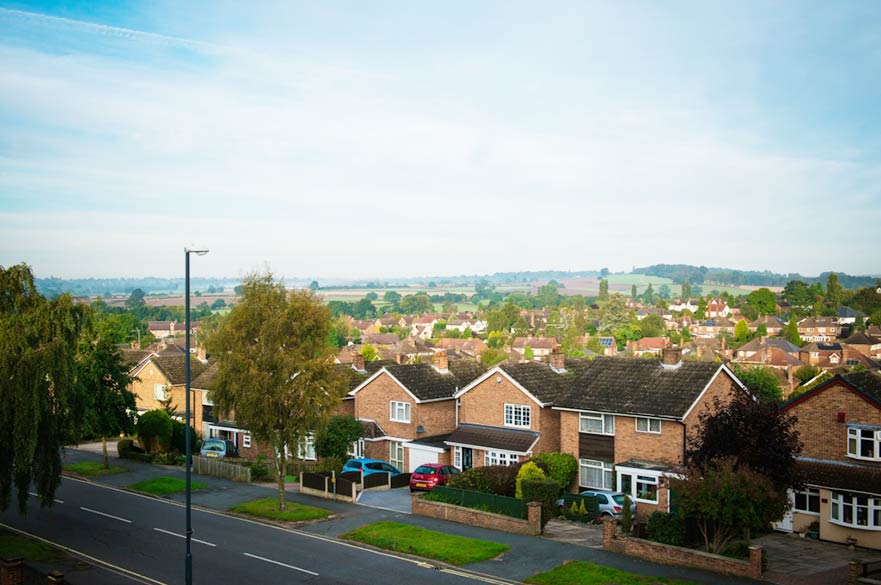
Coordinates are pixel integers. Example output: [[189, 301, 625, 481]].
[[0, 264, 87, 512]]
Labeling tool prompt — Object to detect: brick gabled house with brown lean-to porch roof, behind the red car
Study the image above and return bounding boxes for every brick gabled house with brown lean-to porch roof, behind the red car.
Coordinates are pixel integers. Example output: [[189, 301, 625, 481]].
[[446, 351, 586, 470]]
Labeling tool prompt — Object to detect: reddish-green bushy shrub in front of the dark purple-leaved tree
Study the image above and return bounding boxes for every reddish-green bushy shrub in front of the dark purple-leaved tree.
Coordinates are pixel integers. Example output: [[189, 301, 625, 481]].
[[671, 459, 789, 553]]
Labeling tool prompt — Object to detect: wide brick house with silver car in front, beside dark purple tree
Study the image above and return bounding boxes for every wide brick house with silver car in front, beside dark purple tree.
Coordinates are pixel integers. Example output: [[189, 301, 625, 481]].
[[553, 348, 746, 518]]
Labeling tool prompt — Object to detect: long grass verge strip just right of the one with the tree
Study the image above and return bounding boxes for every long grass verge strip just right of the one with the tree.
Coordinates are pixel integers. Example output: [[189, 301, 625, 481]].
[[342, 522, 511, 565]]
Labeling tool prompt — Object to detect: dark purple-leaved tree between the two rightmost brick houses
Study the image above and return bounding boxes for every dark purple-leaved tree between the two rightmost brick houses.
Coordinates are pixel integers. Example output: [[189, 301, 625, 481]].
[[686, 393, 802, 493]]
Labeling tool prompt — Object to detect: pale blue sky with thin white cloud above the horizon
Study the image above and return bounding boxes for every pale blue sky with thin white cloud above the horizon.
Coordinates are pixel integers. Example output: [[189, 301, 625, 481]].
[[0, 0, 881, 278]]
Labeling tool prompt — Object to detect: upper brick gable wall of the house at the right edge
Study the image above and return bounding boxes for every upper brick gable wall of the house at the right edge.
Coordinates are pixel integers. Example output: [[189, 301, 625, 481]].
[[789, 383, 881, 461]]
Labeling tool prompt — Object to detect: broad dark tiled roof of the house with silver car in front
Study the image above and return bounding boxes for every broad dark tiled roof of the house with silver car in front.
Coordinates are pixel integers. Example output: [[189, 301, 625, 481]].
[[555, 357, 721, 418]]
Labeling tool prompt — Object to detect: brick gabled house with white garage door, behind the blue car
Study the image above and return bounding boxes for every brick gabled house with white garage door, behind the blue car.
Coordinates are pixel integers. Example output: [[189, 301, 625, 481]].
[[349, 351, 485, 471]]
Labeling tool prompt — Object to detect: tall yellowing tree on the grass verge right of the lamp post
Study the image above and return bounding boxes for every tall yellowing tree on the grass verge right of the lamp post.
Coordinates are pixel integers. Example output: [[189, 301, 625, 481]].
[[206, 273, 346, 510]]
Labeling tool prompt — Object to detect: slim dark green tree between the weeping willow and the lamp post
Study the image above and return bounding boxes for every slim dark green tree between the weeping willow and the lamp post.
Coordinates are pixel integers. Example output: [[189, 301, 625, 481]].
[[76, 338, 137, 469]]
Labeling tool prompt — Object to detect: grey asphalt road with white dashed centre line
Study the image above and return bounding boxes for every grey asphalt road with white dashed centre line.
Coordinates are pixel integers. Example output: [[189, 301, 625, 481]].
[[0, 478, 506, 585]]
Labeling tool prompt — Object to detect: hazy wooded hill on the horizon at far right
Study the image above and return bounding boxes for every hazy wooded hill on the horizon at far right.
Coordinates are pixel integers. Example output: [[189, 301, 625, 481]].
[[633, 264, 877, 288]]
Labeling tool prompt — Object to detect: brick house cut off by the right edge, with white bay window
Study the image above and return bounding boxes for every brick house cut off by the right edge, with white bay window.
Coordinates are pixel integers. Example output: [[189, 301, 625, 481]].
[[777, 372, 881, 549]]
